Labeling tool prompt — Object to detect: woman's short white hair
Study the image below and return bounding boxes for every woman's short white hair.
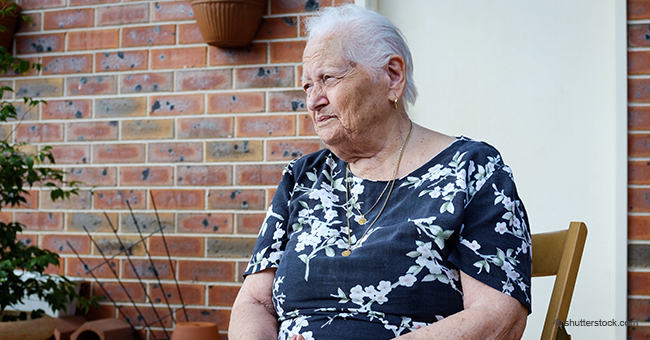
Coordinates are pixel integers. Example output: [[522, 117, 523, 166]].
[[305, 4, 418, 108]]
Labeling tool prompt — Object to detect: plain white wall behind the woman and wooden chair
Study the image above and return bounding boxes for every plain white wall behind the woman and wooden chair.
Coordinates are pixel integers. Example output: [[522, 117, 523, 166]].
[[358, 0, 627, 339]]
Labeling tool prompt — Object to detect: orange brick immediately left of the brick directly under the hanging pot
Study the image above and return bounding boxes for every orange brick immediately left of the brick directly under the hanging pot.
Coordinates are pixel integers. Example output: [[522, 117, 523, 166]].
[[151, 46, 207, 69]]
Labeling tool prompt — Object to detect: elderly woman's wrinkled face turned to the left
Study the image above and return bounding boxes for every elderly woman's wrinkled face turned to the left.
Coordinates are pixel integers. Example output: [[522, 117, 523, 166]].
[[302, 36, 391, 148]]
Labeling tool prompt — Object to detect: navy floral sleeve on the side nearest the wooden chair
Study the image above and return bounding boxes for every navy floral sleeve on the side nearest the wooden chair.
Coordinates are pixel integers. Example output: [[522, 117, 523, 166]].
[[449, 153, 532, 313]]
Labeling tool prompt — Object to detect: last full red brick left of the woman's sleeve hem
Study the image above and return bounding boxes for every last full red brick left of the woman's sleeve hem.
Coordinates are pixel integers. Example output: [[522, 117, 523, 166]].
[[178, 260, 235, 282]]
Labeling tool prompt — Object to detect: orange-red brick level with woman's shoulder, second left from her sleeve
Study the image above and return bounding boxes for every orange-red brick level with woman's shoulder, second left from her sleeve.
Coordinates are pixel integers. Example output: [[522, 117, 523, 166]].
[[176, 165, 232, 186]]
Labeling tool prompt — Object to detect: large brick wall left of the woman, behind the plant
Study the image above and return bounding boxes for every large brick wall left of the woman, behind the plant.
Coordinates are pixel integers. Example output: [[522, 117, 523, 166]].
[[0, 0, 353, 338]]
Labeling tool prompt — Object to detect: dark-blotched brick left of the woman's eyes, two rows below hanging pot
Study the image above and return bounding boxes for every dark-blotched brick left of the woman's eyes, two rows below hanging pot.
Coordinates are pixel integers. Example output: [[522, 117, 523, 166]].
[[235, 66, 294, 88]]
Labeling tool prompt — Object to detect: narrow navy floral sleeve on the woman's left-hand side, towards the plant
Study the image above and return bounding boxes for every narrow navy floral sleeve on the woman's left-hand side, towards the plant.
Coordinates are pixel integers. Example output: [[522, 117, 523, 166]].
[[244, 161, 295, 276]]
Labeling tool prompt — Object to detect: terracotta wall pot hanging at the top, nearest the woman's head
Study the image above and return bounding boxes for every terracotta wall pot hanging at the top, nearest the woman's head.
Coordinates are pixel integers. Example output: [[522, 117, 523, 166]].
[[191, 0, 267, 47]]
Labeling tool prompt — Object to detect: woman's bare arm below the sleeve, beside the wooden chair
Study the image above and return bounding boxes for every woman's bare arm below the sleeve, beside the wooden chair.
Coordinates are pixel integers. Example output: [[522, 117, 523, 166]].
[[397, 271, 528, 340]]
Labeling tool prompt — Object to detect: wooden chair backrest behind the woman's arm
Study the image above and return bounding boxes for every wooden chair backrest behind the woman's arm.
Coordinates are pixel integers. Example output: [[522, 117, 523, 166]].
[[532, 222, 587, 340]]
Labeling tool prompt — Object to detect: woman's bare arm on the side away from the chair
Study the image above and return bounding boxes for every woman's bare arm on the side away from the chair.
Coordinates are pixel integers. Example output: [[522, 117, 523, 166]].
[[228, 268, 278, 340]]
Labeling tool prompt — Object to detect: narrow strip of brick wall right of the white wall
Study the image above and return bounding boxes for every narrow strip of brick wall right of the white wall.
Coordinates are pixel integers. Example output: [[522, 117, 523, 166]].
[[627, 0, 650, 339]]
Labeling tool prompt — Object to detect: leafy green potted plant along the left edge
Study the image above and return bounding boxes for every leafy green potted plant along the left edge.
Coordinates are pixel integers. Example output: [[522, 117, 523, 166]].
[[0, 43, 96, 340]]
